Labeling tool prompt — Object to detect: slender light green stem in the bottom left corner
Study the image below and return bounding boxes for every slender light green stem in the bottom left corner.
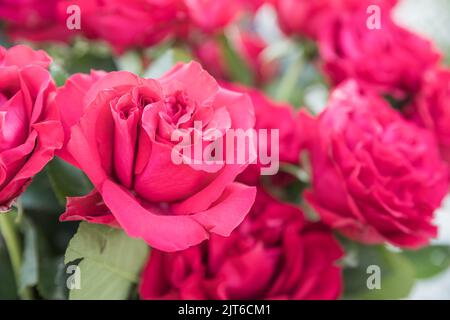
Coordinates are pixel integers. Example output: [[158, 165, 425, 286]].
[[0, 211, 33, 300]]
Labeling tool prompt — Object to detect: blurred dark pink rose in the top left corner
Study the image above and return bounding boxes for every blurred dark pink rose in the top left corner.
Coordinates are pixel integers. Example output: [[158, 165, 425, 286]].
[[0, 0, 73, 41]]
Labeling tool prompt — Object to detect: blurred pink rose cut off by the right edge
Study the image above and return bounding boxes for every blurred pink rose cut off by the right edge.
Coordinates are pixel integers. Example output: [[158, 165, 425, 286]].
[[406, 69, 450, 164]]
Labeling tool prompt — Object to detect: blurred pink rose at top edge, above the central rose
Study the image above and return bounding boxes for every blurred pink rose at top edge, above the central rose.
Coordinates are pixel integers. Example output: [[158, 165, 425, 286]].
[[58, 0, 187, 53]]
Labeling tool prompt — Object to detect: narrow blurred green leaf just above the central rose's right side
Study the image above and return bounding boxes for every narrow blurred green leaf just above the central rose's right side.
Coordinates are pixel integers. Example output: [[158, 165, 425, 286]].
[[218, 34, 254, 86]]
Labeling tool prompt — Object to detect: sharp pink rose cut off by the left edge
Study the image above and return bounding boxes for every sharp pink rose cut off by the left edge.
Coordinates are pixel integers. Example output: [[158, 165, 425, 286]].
[[0, 45, 63, 211]]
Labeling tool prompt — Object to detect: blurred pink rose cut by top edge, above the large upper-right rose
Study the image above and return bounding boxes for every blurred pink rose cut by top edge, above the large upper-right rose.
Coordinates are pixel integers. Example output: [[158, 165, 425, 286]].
[[272, 0, 397, 39]]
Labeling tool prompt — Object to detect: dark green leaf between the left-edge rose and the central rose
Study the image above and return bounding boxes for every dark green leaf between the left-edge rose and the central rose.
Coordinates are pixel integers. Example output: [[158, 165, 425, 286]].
[[46, 158, 92, 205]]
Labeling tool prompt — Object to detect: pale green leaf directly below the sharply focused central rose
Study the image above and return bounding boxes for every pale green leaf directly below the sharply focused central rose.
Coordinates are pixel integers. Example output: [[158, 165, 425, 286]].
[[64, 222, 148, 300]]
